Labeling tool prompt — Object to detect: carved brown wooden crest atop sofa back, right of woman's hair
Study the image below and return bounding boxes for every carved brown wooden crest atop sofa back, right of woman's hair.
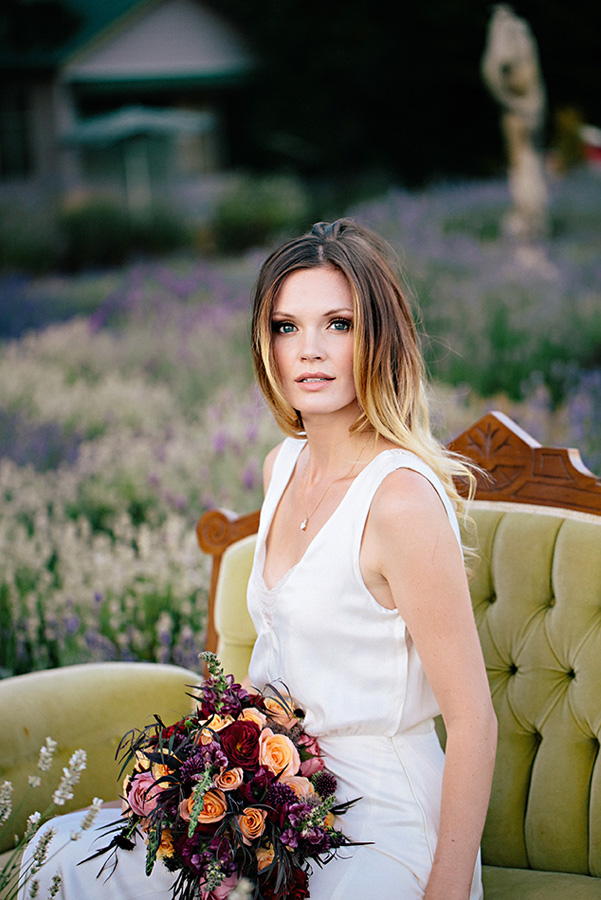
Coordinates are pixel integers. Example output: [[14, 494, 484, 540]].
[[449, 412, 601, 515]]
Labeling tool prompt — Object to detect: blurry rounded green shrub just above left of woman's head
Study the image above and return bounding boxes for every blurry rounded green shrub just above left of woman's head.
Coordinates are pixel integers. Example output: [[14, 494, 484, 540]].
[[212, 176, 311, 253]]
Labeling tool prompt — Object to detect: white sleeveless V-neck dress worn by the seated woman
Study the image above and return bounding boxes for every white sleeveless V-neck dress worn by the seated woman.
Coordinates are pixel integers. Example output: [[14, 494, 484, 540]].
[[19, 439, 482, 900]]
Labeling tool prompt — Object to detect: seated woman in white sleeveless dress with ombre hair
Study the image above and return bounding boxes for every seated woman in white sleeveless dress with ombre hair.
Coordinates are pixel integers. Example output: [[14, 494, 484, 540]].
[[21, 219, 496, 900]]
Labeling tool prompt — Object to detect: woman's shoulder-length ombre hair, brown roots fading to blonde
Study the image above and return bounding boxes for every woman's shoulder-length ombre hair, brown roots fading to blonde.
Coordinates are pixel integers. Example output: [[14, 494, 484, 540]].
[[252, 219, 475, 509]]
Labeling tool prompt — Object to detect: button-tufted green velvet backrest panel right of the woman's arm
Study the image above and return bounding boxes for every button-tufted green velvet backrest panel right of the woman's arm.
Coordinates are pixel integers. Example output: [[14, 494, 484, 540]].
[[471, 509, 601, 880]]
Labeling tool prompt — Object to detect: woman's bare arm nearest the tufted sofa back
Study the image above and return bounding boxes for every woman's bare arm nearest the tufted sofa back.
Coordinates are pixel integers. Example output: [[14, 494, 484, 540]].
[[370, 469, 497, 900]]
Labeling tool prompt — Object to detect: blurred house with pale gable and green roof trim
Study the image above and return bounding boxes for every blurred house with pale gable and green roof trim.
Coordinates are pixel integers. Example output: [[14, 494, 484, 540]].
[[0, 0, 253, 213]]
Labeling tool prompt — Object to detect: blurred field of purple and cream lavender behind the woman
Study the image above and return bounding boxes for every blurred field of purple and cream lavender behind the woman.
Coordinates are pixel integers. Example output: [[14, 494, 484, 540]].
[[0, 172, 601, 675]]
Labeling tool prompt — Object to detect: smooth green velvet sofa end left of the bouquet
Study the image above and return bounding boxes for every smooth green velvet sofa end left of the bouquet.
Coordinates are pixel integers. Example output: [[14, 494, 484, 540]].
[[0, 662, 200, 856]]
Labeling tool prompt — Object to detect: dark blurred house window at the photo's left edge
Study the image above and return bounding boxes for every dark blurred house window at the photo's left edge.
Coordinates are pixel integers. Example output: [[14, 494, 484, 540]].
[[0, 85, 33, 179]]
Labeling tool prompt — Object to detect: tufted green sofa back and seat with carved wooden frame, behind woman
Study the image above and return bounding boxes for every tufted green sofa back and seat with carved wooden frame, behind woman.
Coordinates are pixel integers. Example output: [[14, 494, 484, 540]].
[[198, 414, 601, 900]]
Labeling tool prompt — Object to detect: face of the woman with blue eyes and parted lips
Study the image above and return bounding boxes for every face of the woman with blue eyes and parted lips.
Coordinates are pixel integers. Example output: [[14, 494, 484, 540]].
[[271, 266, 358, 425]]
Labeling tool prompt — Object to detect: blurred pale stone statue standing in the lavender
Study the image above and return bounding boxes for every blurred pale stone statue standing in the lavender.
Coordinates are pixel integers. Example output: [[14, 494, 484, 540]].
[[482, 3, 548, 242]]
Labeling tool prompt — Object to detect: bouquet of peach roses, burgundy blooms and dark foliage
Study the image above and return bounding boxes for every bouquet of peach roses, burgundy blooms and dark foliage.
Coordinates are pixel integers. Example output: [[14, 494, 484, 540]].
[[90, 654, 355, 900]]
